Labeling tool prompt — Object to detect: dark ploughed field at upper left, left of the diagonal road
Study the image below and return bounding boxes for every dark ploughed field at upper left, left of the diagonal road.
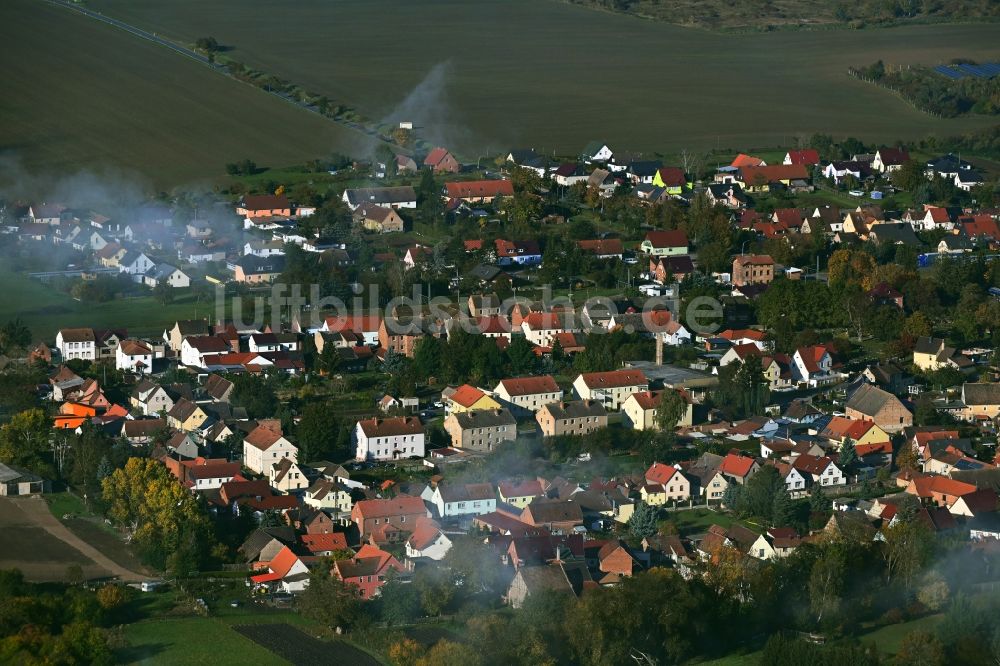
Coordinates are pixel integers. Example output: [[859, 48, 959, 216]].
[[0, 0, 370, 187]]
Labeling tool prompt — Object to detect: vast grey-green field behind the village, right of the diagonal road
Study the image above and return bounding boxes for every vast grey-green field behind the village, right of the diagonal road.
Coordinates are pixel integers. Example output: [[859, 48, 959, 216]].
[[89, 0, 1000, 159]]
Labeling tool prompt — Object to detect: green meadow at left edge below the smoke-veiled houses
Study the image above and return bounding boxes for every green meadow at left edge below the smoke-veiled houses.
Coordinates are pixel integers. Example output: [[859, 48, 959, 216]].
[[0, 268, 214, 341]]
